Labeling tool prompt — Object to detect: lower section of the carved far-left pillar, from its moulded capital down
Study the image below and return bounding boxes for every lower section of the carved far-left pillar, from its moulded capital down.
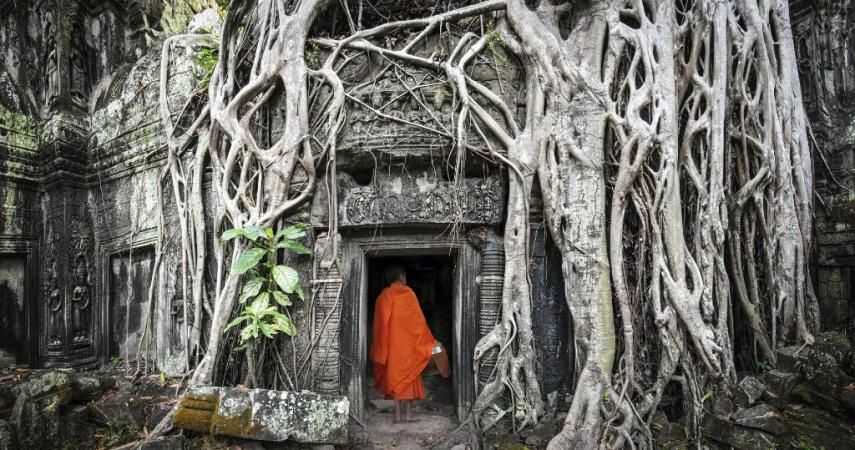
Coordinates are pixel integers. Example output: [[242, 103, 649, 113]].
[[40, 112, 100, 367]]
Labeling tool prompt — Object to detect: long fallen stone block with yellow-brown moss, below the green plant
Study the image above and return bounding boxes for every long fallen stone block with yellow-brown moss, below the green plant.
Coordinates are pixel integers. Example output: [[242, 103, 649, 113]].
[[173, 387, 350, 444]]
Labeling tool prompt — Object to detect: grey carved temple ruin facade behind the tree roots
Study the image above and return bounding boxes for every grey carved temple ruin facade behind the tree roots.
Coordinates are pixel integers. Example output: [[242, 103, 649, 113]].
[[0, 0, 855, 430]]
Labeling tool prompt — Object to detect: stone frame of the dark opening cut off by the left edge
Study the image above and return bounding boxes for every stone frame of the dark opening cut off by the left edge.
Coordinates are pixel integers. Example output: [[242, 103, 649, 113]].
[[0, 235, 39, 368]]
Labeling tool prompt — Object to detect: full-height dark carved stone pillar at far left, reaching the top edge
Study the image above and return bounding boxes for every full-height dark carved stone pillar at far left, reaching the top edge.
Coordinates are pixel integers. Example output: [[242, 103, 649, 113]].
[[39, 0, 101, 367]]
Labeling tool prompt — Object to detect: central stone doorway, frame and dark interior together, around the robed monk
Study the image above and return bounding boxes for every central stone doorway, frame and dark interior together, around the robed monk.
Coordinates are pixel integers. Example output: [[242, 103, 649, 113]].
[[340, 231, 480, 420]]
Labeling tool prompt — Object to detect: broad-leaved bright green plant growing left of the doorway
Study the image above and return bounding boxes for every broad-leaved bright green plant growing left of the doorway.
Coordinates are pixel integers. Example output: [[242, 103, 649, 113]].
[[221, 224, 312, 349]]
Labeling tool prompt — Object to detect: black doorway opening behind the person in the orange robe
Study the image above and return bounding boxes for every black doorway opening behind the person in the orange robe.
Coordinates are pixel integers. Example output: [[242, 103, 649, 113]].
[[366, 254, 457, 416]]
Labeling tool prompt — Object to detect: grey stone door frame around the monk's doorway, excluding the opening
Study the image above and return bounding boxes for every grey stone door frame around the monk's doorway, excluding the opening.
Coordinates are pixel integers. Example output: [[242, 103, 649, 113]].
[[340, 229, 481, 421]]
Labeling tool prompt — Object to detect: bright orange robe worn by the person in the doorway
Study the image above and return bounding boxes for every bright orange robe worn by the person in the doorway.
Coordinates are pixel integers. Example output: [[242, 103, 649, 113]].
[[370, 283, 436, 400]]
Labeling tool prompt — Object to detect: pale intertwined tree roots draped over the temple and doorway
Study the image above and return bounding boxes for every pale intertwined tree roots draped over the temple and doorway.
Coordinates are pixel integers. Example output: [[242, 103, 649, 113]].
[[150, 0, 815, 448]]
